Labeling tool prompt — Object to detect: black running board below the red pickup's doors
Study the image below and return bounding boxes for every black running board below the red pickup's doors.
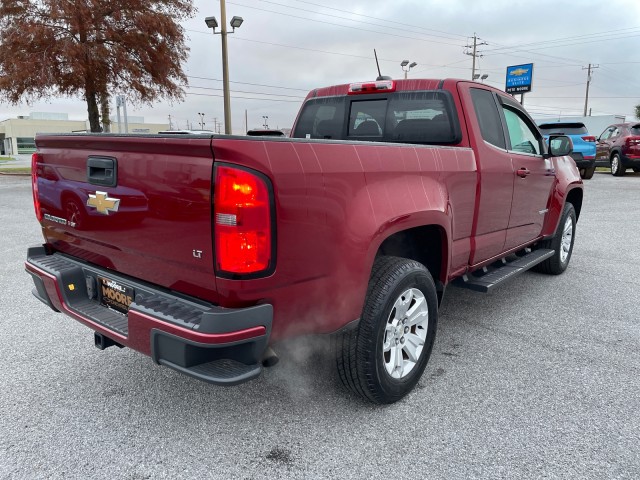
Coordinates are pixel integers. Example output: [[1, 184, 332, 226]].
[[452, 249, 555, 293]]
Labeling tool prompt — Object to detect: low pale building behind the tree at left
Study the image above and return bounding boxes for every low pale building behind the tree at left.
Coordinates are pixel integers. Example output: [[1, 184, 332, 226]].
[[0, 112, 169, 155]]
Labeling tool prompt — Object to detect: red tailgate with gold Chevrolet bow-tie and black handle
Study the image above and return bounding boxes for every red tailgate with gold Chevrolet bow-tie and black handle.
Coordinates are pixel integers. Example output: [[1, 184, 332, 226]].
[[35, 135, 217, 302]]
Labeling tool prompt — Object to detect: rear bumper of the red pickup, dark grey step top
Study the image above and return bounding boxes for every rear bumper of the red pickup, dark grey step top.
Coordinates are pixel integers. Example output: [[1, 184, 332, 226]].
[[25, 247, 273, 385]]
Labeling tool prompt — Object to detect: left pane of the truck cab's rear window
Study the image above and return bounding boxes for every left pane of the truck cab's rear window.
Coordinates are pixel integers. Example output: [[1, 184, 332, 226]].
[[293, 97, 345, 139]]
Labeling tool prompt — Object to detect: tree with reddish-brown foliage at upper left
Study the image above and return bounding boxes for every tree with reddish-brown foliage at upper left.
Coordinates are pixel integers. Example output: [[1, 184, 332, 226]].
[[0, 0, 194, 132]]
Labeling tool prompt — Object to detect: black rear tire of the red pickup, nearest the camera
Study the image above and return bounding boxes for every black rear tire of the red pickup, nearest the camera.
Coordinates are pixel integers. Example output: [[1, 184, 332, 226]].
[[334, 257, 438, 403]]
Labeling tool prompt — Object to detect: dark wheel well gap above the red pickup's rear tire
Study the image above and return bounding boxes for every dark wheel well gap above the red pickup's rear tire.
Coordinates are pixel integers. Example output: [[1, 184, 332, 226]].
[[376, 225, 447, 295]]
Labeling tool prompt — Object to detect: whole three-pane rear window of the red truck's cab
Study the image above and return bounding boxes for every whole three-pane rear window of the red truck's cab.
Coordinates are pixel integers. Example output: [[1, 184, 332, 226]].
[[293, 91, 461, 144]]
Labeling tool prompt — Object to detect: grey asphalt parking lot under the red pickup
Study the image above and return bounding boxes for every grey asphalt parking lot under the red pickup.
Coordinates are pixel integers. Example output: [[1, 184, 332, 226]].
[[0, 172, 640, 479]]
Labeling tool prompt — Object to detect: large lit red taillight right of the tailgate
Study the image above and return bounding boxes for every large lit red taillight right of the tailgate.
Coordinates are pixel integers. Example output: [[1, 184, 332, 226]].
[[213, 166, 273, 275]]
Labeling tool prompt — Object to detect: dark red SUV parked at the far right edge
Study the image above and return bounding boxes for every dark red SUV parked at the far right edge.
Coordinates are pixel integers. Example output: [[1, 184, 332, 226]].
[[596, 122, 640, 177]]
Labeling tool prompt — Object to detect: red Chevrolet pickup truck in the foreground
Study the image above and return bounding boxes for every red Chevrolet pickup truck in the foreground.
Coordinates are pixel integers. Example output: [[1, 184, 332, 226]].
[[26, 79, 583, 403]]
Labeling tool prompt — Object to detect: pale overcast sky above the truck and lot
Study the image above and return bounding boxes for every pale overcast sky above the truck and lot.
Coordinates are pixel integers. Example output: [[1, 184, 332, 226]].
[[0, 0, 640, 134]]
